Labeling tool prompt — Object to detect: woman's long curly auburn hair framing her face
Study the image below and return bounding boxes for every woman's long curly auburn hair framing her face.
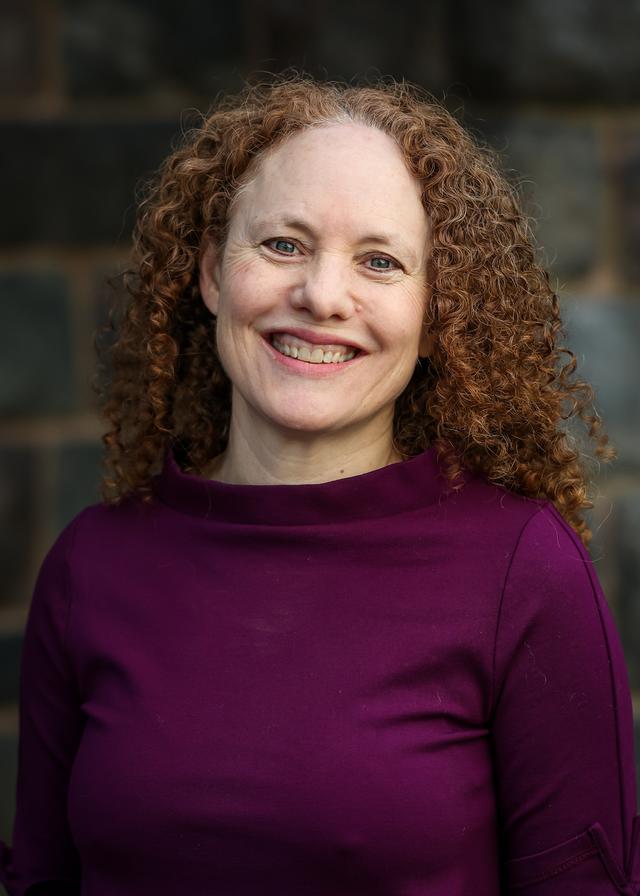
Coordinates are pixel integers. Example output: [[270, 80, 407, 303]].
[[94, 70, 614, 544]]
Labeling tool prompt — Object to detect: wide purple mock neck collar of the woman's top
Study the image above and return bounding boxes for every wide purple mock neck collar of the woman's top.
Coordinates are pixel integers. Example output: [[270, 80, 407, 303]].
[[152, 446, 447, 526]]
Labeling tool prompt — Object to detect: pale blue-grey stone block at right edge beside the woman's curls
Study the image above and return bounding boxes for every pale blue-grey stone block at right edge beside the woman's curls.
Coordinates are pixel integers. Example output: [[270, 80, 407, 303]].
[[562, 297, 640, 472]]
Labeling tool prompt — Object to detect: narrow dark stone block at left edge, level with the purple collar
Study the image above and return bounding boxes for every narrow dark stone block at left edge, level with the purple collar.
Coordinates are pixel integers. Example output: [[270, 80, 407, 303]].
[[0, 445, 35, 604]]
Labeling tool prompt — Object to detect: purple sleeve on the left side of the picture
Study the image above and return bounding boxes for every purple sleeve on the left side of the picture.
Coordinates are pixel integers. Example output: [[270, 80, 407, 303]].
[[0, 517, 83, 896]]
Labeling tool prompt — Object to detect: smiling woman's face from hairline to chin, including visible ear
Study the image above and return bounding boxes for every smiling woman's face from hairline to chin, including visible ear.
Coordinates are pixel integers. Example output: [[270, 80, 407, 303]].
[[200, 124, 429, 441]]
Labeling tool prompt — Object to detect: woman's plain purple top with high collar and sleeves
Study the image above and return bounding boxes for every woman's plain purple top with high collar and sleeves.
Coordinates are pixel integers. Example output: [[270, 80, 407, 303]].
[[0, 449, 640, 896]]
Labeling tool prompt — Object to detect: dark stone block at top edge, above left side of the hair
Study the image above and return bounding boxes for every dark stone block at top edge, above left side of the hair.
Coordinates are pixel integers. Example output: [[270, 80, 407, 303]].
[[62, 0, 245, 97]]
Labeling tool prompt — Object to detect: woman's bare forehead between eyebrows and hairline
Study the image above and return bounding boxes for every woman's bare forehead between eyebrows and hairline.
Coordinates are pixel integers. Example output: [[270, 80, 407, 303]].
[[231, 123, 428, 245]]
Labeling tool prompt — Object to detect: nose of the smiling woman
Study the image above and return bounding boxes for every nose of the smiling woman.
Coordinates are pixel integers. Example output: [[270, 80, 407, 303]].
[[291, 252, 355, 320]]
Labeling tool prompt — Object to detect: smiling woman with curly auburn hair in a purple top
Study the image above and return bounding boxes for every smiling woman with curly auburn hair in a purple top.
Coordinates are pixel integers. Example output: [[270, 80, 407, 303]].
[[4, 74, 640, 896]]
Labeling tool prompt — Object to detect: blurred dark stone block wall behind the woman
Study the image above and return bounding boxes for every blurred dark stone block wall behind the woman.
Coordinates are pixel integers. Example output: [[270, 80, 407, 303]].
[[0, 0, 640, 841]]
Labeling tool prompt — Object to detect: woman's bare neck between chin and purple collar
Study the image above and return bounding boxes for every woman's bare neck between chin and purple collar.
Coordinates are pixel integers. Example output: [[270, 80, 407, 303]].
[[204, 406, 402, 485]]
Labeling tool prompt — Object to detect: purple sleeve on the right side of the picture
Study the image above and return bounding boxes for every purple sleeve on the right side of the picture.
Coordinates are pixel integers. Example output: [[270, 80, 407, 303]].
[[492, 505, 640, 896]]
